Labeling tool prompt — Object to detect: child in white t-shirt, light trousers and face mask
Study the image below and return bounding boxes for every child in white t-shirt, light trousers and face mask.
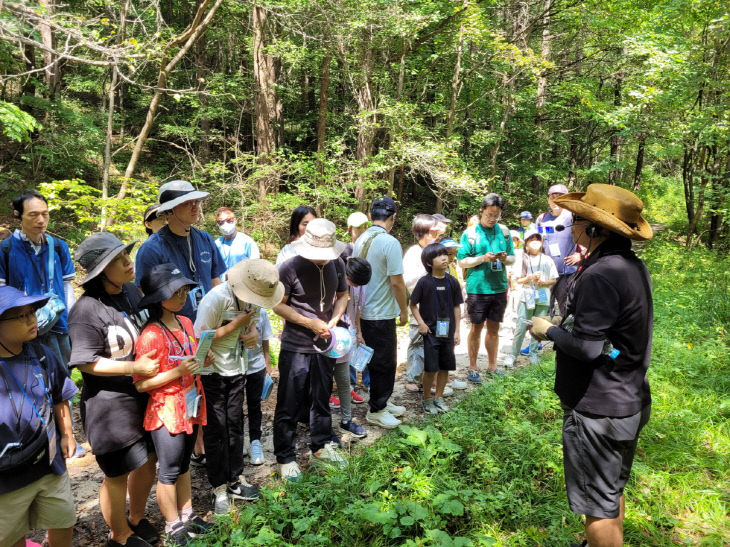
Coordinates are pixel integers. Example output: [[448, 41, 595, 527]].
[[504, 232, 558, 367]]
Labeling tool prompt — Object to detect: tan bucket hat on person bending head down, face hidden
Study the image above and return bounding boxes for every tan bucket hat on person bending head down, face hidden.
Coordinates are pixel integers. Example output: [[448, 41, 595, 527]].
[[228, 258, 284, 309]]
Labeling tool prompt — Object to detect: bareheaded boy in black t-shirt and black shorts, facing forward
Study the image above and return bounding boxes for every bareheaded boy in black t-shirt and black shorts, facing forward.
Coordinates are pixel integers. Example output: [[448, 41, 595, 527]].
[[410, 243, 464, 414]]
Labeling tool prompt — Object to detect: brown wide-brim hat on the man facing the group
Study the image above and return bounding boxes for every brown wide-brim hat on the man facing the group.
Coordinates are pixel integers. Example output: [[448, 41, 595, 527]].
[[554, 184, 654, 241]]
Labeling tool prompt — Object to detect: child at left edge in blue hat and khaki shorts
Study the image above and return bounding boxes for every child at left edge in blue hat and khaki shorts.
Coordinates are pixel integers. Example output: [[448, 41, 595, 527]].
[[0, 286, 78, 547]]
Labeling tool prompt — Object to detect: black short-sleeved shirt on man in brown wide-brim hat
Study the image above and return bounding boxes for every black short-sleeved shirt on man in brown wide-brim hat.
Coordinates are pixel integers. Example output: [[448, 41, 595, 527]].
[[555, 238, 653, 417]]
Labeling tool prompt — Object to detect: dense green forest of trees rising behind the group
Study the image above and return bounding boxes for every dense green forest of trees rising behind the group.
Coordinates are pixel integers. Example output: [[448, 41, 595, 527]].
[[0, 0, 730, 248]]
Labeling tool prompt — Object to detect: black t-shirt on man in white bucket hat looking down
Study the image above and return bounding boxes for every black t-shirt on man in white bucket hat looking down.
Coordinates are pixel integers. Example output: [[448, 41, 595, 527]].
[[279, 256, 347, 353]]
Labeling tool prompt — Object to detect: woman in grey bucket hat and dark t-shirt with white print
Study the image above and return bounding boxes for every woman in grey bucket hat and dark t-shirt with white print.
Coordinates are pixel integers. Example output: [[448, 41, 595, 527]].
[[69, 232, 159, 547]]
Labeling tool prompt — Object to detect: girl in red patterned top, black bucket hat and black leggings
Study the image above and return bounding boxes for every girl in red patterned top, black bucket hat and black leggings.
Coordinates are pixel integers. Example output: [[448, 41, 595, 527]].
[[133, 264, 213, 545]]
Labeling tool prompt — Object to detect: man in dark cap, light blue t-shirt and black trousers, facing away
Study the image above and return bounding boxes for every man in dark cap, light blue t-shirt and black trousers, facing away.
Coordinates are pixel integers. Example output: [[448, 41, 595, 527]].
[[352, 196, 408, 429]]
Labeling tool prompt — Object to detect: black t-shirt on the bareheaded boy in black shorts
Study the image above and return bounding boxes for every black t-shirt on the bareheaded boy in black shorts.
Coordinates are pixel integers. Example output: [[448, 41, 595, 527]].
[[411, 274, 464, 339]]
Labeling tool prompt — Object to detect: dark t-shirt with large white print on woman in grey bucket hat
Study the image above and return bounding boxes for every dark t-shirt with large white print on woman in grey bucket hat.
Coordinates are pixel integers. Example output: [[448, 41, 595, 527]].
[[69, 283, 147, 454]]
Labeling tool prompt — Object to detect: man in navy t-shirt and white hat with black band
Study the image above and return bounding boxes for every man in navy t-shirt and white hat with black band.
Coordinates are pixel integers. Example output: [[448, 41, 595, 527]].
[[135, 180, 226, 322]]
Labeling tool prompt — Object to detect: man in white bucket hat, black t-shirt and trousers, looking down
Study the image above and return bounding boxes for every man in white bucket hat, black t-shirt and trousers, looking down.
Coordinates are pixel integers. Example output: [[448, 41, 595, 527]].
[[273, 218, 348, 480]]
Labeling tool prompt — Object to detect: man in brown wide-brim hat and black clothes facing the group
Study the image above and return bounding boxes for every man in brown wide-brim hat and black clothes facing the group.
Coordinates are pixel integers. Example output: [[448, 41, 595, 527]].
[[531, 184, 653, 547]]
